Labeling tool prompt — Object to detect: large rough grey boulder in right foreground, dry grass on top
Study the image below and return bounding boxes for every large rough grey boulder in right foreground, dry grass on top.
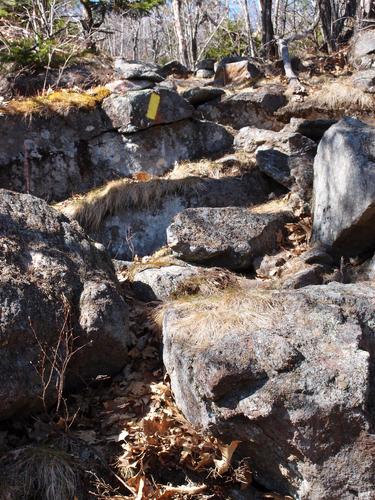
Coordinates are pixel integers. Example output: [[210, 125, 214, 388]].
[[163, 283, 375, 500]]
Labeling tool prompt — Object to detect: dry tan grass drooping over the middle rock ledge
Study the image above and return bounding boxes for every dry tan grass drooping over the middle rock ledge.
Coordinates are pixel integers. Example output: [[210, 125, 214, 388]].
[[54, 177, 204, 231]]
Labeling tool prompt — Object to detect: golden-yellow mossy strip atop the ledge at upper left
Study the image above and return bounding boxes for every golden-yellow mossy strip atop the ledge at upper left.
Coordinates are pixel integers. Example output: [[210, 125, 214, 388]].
[[1, 87, 110, 116]]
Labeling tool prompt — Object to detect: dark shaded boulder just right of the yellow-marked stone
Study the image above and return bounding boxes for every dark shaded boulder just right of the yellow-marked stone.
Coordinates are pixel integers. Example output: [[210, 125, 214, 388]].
[[198, 85, 286, 130]]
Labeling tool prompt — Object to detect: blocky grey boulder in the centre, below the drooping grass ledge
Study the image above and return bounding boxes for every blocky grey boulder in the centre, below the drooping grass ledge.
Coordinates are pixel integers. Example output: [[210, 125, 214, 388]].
[[167, 207, 293, 270]]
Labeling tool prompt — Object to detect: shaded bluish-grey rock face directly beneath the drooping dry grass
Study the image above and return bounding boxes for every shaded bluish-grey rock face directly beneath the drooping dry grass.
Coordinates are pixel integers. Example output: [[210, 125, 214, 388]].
[[63, 171, 271, 260]]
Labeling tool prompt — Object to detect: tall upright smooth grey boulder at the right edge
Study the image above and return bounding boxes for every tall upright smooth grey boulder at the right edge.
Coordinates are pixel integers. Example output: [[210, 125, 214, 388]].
[[313, 118, 375, 255]]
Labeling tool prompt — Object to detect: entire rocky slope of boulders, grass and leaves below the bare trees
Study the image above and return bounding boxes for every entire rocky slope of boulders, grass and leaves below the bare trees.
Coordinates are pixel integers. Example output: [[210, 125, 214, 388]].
[[0, 32, 375, 500]]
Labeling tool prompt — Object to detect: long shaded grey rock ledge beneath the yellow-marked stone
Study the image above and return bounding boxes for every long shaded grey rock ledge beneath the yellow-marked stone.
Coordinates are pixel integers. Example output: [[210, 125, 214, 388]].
[[0, 109, 233, 201]]
